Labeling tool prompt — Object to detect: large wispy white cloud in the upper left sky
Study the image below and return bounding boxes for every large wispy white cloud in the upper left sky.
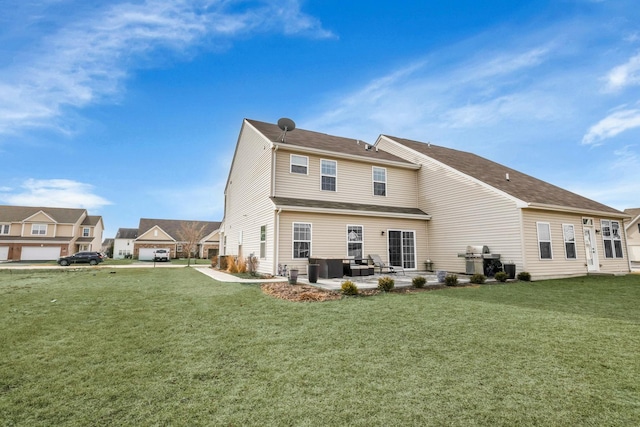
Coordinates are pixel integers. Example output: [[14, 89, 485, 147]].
[[0, 0, 333, 134]]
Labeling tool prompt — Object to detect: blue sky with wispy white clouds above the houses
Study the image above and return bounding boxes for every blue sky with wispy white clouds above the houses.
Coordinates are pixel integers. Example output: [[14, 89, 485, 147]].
[[0, 0, 640, 237]]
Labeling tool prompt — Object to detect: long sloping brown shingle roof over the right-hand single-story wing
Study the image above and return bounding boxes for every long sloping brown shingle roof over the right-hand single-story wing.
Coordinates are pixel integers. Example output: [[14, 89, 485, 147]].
[[385, 135, 622, 215]]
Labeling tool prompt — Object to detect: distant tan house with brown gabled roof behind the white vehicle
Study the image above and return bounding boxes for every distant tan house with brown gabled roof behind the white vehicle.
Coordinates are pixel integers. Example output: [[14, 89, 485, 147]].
[[133, 218, 220, 260]]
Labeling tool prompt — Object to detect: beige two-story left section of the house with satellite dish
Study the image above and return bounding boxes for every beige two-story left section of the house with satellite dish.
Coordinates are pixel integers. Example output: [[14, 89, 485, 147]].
[[221, 120, 430, 274]]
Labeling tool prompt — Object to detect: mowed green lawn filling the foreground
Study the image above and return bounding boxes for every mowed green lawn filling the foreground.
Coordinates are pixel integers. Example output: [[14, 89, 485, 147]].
[[0, 268, 640, 426]]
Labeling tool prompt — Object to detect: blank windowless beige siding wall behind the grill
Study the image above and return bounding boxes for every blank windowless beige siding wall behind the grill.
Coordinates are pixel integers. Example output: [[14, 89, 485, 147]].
[[379, 138, 524, 272]]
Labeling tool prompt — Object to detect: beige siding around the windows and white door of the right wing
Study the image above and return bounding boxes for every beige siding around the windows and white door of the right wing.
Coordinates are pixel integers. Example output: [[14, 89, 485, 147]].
[[523, 209, 629, 279]]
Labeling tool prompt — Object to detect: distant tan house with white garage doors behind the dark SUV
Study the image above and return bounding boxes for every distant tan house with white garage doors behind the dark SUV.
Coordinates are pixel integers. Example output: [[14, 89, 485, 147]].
[[0, 206, 104, 261]]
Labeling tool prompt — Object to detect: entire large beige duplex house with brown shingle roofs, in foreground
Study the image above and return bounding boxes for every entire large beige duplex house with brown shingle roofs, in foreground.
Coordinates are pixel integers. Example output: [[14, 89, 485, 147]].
[[221, 120, 629, 278]]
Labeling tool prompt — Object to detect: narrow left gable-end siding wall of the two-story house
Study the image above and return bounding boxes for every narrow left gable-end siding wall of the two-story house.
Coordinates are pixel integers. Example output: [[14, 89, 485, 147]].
[[220, 122, 275, 273]]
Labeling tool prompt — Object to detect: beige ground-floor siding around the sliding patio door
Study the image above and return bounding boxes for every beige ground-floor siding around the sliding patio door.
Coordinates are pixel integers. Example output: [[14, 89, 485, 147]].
[[279, 212, 427, 274]]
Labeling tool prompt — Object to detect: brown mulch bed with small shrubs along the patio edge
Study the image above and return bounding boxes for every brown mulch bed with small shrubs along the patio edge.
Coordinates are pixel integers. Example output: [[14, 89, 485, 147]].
[[260, 282, 468, 302]]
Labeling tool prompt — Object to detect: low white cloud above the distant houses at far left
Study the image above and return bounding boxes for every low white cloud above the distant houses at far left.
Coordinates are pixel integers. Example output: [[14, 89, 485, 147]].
[[0, 179, 111, 210]]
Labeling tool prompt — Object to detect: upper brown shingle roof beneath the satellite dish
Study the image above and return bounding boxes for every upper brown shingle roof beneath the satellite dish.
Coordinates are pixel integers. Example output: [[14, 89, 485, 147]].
[[246, 119, 413, 165]]
